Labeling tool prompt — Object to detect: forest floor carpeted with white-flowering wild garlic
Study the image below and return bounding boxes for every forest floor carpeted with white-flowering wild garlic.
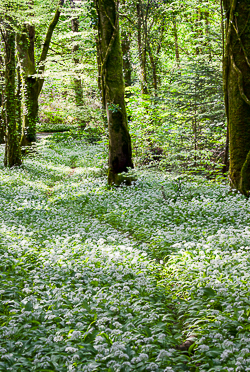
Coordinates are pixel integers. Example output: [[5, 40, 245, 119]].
[[0, 134, 250, 372]]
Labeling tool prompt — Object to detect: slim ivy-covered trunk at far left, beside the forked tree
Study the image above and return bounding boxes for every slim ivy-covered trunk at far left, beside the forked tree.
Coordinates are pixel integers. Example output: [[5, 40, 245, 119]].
[[4, 27, 22, 167]]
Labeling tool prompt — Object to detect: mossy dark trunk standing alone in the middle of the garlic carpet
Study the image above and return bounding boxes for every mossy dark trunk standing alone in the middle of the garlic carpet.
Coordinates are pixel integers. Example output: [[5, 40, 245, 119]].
[[96, 0, 133, 185]]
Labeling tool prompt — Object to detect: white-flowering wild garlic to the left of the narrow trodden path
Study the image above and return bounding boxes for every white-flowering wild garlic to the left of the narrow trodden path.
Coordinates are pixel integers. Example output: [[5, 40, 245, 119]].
[[0, 134, 187, 372]]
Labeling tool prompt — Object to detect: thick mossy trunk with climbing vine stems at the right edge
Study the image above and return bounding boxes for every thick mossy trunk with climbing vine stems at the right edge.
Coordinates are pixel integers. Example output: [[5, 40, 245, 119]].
[[223, 0, 250, 196]]
